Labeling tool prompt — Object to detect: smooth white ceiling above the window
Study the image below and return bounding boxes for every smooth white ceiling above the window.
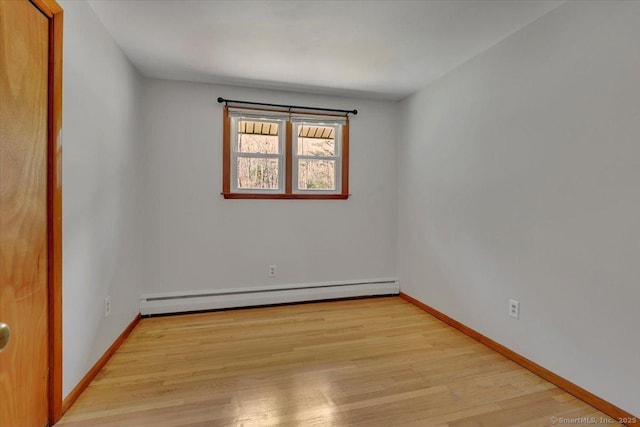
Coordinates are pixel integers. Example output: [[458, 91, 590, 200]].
[[90, 0, 563, 99]]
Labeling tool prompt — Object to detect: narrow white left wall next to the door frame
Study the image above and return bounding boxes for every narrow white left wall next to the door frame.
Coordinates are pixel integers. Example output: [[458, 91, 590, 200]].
[[60, 0, 141, 396]]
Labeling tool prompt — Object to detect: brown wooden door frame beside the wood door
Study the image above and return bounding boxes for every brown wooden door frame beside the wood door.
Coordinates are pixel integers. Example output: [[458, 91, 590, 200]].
[[30, 0, 63, 425]]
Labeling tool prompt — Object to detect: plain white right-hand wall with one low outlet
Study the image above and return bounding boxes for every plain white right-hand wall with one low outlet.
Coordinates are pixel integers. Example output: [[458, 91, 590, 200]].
[[398, 1, 640, 414]]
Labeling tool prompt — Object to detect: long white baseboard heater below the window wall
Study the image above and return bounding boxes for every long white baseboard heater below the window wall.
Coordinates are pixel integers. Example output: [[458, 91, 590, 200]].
[[140, 279, 400, 316]]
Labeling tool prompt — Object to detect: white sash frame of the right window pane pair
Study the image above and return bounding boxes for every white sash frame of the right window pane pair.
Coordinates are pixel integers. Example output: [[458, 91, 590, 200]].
[[291, 120, 342, 194]]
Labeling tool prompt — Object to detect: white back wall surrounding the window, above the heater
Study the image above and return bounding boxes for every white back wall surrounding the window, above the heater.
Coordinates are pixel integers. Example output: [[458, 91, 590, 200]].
[[143, 80, 397, 293]]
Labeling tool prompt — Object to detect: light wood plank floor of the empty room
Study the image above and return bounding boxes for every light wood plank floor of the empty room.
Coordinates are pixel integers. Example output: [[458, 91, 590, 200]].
[[56, 297, 617, 427]]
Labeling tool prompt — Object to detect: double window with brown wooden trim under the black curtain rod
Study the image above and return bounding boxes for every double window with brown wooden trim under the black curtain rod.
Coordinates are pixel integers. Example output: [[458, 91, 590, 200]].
[[222, 106, 349, 199]]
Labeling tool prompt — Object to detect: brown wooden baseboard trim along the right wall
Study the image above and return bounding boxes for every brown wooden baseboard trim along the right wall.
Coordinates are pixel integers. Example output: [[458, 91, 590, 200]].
[[399, 292, 640, 426]]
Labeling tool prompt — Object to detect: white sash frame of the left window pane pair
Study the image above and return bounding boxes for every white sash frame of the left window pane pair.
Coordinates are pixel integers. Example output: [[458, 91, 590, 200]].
[[230, 116, 286, 194]]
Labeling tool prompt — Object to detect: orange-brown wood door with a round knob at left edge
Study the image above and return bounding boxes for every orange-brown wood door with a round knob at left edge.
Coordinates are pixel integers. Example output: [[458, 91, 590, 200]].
[[0, 0, 49, 427]]
